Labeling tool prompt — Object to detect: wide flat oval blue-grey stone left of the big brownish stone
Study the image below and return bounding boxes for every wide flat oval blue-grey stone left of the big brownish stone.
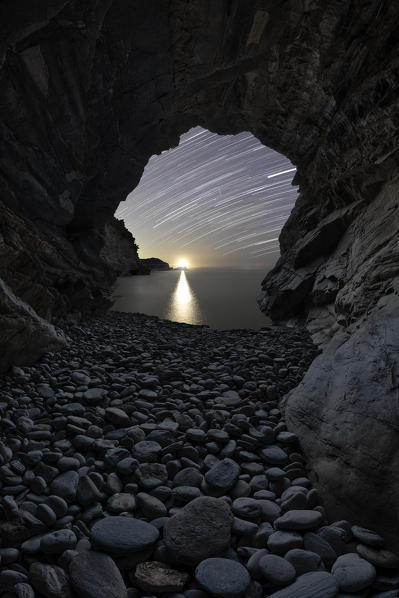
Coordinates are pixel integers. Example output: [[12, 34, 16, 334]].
[[91, 517, 159, 555]]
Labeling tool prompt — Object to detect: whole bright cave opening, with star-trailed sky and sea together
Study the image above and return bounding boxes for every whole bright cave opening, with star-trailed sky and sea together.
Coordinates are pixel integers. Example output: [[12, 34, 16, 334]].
[[111, 127, 297, 329]]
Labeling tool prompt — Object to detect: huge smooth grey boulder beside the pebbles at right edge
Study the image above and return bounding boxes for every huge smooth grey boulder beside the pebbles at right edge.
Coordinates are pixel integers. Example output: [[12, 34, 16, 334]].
[[285, 294, 399, 545]]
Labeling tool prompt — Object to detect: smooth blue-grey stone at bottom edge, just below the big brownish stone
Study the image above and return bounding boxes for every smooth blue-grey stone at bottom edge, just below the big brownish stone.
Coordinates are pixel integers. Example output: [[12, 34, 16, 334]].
[[195, 558, 251, 598]]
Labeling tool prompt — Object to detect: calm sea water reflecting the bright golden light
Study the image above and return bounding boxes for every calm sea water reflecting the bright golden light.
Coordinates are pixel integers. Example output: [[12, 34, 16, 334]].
[[113, 269, 270, 330]]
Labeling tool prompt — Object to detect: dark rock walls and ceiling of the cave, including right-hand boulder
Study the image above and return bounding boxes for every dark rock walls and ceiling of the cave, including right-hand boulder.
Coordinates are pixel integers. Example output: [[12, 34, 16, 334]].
[[0, 0, 399, 548]]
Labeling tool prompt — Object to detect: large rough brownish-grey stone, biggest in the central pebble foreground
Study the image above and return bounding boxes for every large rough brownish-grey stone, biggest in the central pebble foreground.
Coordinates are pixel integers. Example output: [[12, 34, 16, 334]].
[[163, 496, 233, 564]]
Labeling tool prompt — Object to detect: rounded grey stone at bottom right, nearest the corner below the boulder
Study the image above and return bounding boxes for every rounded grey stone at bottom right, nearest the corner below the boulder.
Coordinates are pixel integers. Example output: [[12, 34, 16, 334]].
[[331, 552, 376, 592]]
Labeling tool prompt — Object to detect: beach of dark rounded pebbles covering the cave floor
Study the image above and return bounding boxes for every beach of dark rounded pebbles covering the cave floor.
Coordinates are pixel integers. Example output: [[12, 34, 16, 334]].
[[0, 313, 399, 598]]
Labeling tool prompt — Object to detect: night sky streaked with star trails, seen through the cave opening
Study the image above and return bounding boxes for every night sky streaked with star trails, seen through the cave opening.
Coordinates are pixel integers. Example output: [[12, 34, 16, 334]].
[[115, 127, 297, 269]]
